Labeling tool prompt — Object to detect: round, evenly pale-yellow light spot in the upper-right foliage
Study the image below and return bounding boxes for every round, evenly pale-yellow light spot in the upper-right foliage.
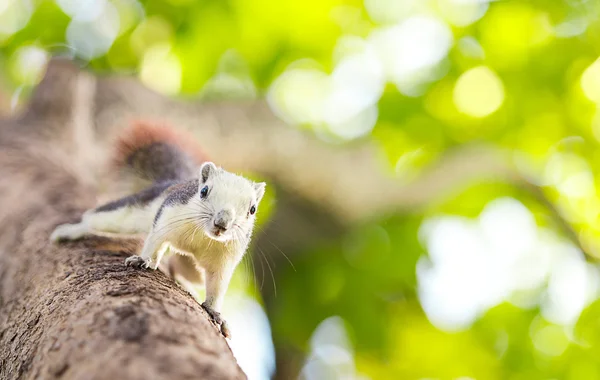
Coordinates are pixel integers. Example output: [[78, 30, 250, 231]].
[[454, 66, 504, 118]]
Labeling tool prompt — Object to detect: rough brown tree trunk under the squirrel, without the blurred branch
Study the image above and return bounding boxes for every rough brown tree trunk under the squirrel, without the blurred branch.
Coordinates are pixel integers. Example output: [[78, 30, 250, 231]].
[[0, 59, 245, 380]]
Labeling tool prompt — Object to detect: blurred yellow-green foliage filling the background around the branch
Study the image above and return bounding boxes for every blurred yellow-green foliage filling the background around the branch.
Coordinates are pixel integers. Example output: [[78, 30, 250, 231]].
[[5, 0, 600, 380]]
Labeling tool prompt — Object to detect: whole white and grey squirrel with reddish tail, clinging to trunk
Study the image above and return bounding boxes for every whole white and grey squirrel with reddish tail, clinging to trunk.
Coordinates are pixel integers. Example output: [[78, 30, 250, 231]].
[[50, 122, 266, 338]]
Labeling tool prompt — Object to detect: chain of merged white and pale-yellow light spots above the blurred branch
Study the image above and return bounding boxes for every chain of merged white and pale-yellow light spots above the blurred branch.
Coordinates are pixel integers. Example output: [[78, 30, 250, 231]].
[[267, 15, 453, 138]]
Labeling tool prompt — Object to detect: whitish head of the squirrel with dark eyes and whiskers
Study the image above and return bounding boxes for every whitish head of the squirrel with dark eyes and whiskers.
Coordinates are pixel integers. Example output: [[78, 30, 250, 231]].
[[198, 162, 266, 242]]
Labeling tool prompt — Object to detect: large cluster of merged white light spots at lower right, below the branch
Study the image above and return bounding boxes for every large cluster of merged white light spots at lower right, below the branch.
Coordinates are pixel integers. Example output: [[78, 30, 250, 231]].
[[417, 198, 599, 331]]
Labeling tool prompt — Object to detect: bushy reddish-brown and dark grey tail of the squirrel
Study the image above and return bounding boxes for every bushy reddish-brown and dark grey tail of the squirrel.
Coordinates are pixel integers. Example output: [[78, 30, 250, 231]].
[[113, 121, 206, 183]]
